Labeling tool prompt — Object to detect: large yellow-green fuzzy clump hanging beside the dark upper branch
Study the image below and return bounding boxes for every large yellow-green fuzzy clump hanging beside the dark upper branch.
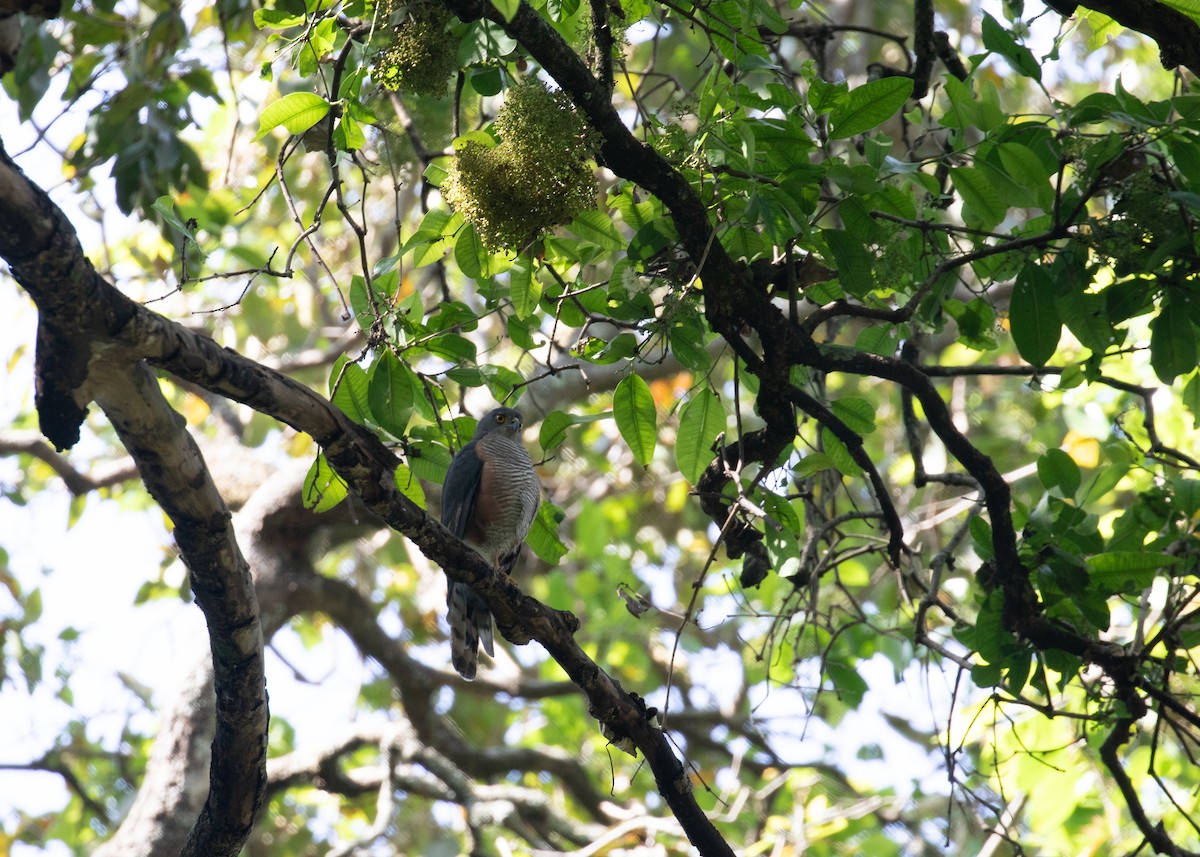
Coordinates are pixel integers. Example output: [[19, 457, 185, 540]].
[[442, 77, 596, 250]]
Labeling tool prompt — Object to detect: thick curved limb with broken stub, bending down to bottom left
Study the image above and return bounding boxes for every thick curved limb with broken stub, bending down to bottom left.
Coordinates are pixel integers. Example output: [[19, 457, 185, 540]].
[[0, 136, 268, 855]]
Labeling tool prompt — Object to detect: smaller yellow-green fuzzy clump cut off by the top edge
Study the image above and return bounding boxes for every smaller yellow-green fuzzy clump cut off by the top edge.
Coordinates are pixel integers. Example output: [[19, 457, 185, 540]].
[[374, 0, 458, 97]]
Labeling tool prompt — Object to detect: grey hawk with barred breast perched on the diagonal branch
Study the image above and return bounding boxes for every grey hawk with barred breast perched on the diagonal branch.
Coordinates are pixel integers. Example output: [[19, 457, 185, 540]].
[[442, 408, 541, 681]]
